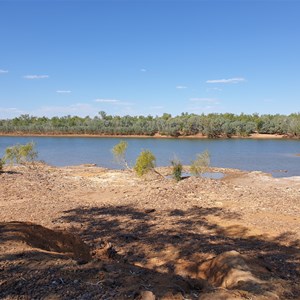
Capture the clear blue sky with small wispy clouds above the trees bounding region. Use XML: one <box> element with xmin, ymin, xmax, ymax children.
<box><xmin>0</xmin><ymin>0</ymin><xmax>300</xmax><ymax>118</ymax></box>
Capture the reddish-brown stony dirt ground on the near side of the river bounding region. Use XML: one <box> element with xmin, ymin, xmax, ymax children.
<box><xmin>0</xmin><ymin>164</ymin><xmax>300</xmax><ymax>300</ymax></box>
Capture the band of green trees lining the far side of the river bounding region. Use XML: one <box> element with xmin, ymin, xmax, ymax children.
<box><xmin>0</xmin><ymin>111</ymin><xmax>300</xmax><ymax>138</ymax></box>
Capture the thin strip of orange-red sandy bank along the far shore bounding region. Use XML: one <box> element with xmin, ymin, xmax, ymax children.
<box><xmin>0</xmin><ymin>132</ymin><xmax>292</xmax><ymax>139</ymax></box>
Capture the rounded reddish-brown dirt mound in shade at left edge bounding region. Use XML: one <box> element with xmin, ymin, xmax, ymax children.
<box><xmin>0</xmin><ymin>222</ymin><xmax>91</xmax><ymax>262</ymax></box>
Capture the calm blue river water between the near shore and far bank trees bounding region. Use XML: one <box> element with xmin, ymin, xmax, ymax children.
<box><xmin>0</xmin><ymin>137</ymin><xmax>300</xmax><ymax>177</ymax></box>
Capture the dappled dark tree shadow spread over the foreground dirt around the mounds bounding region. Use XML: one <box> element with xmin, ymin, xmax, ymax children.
<box><xmin>0</xmin><ymin>206</ymin><xmax>300</xmax><ymax>299</ymax></box>
